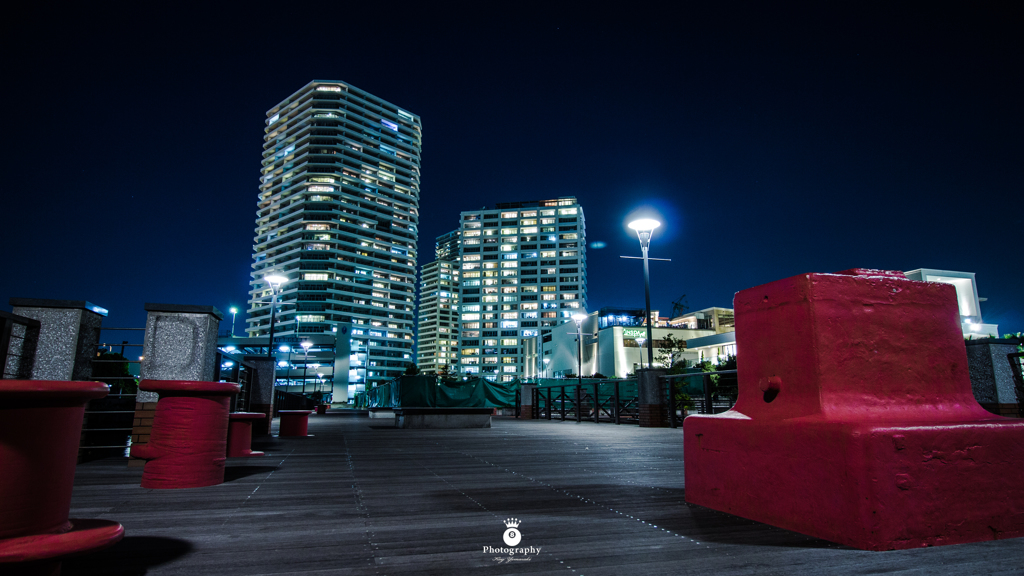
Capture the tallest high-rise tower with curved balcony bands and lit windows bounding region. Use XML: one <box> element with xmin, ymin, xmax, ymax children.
<box><xmin>247</xmin><ymin>80</ymin><xmax>422</xmax><ymax>393</ymax></box>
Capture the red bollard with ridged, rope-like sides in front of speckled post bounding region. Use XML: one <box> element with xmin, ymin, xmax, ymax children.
<box><xmin>131</xmin><ymin>380</ymin><xmax>241</xmax><ymax>489</ymax></box>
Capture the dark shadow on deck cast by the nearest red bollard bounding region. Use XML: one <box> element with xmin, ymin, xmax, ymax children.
<box><xmin>60</xmin><ymin>536</ymin><xmax>193</xmax><ymax>576</ymax></box>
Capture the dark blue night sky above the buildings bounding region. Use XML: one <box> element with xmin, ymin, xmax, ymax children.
<box><xmin>0</xmin><ymin>2</ymin><xmax>1024</xmax><ymax>332</ymax></box>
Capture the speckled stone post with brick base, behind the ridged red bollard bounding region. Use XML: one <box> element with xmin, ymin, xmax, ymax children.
<box><xmin>128</xmin><ymin>303</ymin><xmax>224</xmax><ymax>466</ymax></box>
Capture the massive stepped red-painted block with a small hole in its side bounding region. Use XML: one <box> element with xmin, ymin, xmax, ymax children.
<box><xmin>684</xmin><ymin>270</ymin><xmax>1024</xmax><ymax>550</ymax></box>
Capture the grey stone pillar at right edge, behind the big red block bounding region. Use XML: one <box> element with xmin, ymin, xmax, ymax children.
<box><xmin>966</xmin><ymin>338</ymin><xmax>1021</xmax><ymax>416</ymax></box>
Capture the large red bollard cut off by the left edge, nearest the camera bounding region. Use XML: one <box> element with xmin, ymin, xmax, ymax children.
<box><xmin>0</xmin><ymin>380</ymin><xmax>124</xmax><ymax>574</ymax></box>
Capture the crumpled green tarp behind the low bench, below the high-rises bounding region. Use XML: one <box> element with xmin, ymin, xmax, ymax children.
<box><xmin>356</xmin><ymin>376</ymin><xmax>519</xmax><ymax>408</ymax></box>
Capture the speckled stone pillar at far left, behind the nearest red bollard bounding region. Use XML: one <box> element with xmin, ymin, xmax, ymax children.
<box><xmin>9</xmin><ymin>298</ymin><xmax>106</xmax><ymax>380</ymax></box>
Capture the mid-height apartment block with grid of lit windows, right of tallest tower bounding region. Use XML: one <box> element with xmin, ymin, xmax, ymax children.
<box><xmin>459</xmin><ymin>197</ymin><xmax>587</xmax><ymax>381</ymax></box>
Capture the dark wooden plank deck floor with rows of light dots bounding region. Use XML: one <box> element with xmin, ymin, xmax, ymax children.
<box><xmin>65</xmin><ymin>413</ymin><xmax>1024</xmax><ymax>576</ymax></box>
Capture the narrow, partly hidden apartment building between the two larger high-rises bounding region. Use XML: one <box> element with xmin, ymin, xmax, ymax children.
<box><xmin>416</xmin><ymin>230</ymin><xmax>460</xmax><ymax>374</ymax></box>
